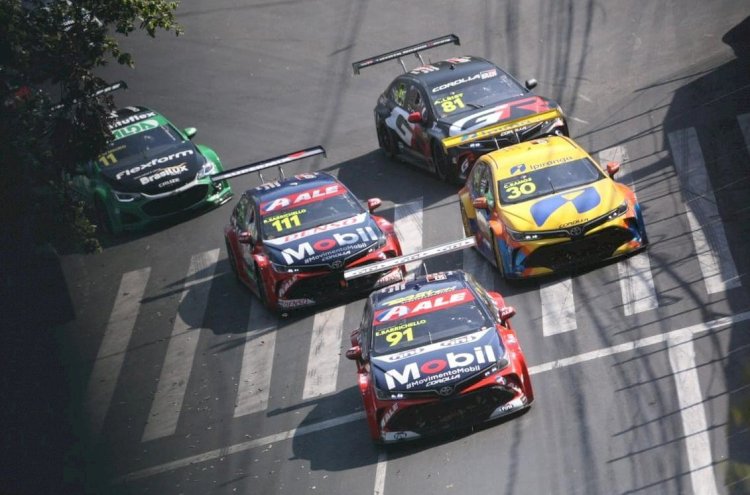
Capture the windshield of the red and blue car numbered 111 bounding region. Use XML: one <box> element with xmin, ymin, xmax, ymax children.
<box><xmin>261</xmin><ymin>185</ymin><xmax>364</xmax><ymax>240</ymax></box>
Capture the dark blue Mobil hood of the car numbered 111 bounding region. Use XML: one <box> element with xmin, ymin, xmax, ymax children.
<box><xmin>264</xmin><ymin>212</ymin><xmax>383</xmax><ymax>269</ymax></box>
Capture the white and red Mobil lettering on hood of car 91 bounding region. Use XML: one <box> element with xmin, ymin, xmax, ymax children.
<box><xmin>384</xmin><ymin>344</ymin><xmax>497</xmax><ymax>390</ymax></box>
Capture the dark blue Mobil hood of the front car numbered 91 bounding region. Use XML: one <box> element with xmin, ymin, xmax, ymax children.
<box><xmin>371</xmin><ymin>327</ymin><xmax>505</xmax><ymax>396</ymax></box>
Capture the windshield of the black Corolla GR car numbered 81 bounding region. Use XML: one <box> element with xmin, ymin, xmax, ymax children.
<box><xmin>430</xmin><ymin>69</ymin><xmax>526</xmax><ymax>118</ymax></box>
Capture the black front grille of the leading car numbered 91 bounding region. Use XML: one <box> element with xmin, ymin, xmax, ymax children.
<box><xmin>388</xmin><ymin>386</ymin><xmax>515</xmax><ymax>435</ymax></box>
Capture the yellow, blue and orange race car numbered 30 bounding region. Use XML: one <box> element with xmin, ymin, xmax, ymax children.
<box><xmin>458</xmin><ymin>136</ymin><xmax>648</xmax><ymax>278</ymax></box>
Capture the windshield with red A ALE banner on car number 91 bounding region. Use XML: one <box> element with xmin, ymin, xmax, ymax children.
<box><xmin>372</xmin><ymin>283</ymin><xmax>492</xmax><ymax>355</ymax></box>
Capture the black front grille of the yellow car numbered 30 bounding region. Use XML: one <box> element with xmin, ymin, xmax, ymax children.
<box><xmin>524</xmin><ymin>227</ymin><xmax>633</xmax><ymax>269</ymax></box>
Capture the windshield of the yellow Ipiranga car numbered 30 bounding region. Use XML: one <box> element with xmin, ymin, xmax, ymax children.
<box><xmin>497</xmin><ymin>158</ymin><xmax>604</xmax><ymax>205</ymax></box>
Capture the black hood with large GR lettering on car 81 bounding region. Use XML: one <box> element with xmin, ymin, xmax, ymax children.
<box><xmin>437</xmin><ymin>96</ymin><xmax>559</xmax><ymax>136</ymax></box>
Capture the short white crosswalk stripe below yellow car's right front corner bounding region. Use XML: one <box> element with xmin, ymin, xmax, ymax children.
<box><xmin>617</xmin><ymin>253</ymin><xmax>659</xmax><ymax>316</ymax></box>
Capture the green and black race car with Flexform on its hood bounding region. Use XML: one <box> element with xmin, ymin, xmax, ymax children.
<box><xmin>70</xmin><ymin>107</ymin><xmax>232</xmax><ymax>234</ymax></box>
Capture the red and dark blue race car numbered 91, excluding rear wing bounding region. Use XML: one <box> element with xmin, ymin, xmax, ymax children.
<box><xmin>346</xmin><ymin>271</ymin><xmax>534</xmax><ymax>443</ymax></box>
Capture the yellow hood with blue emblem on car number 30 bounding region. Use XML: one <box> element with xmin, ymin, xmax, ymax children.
<box><xmin>500</xmin><ymin>179</ymin><xmax>625</xmax><ymax>232</ymax></box>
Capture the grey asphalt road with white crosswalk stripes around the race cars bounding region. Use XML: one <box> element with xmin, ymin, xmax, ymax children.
<box><xmin>10</xmin><ymin>0</ymin><xmax>750</xmax><ymax>495</ymax></box>
